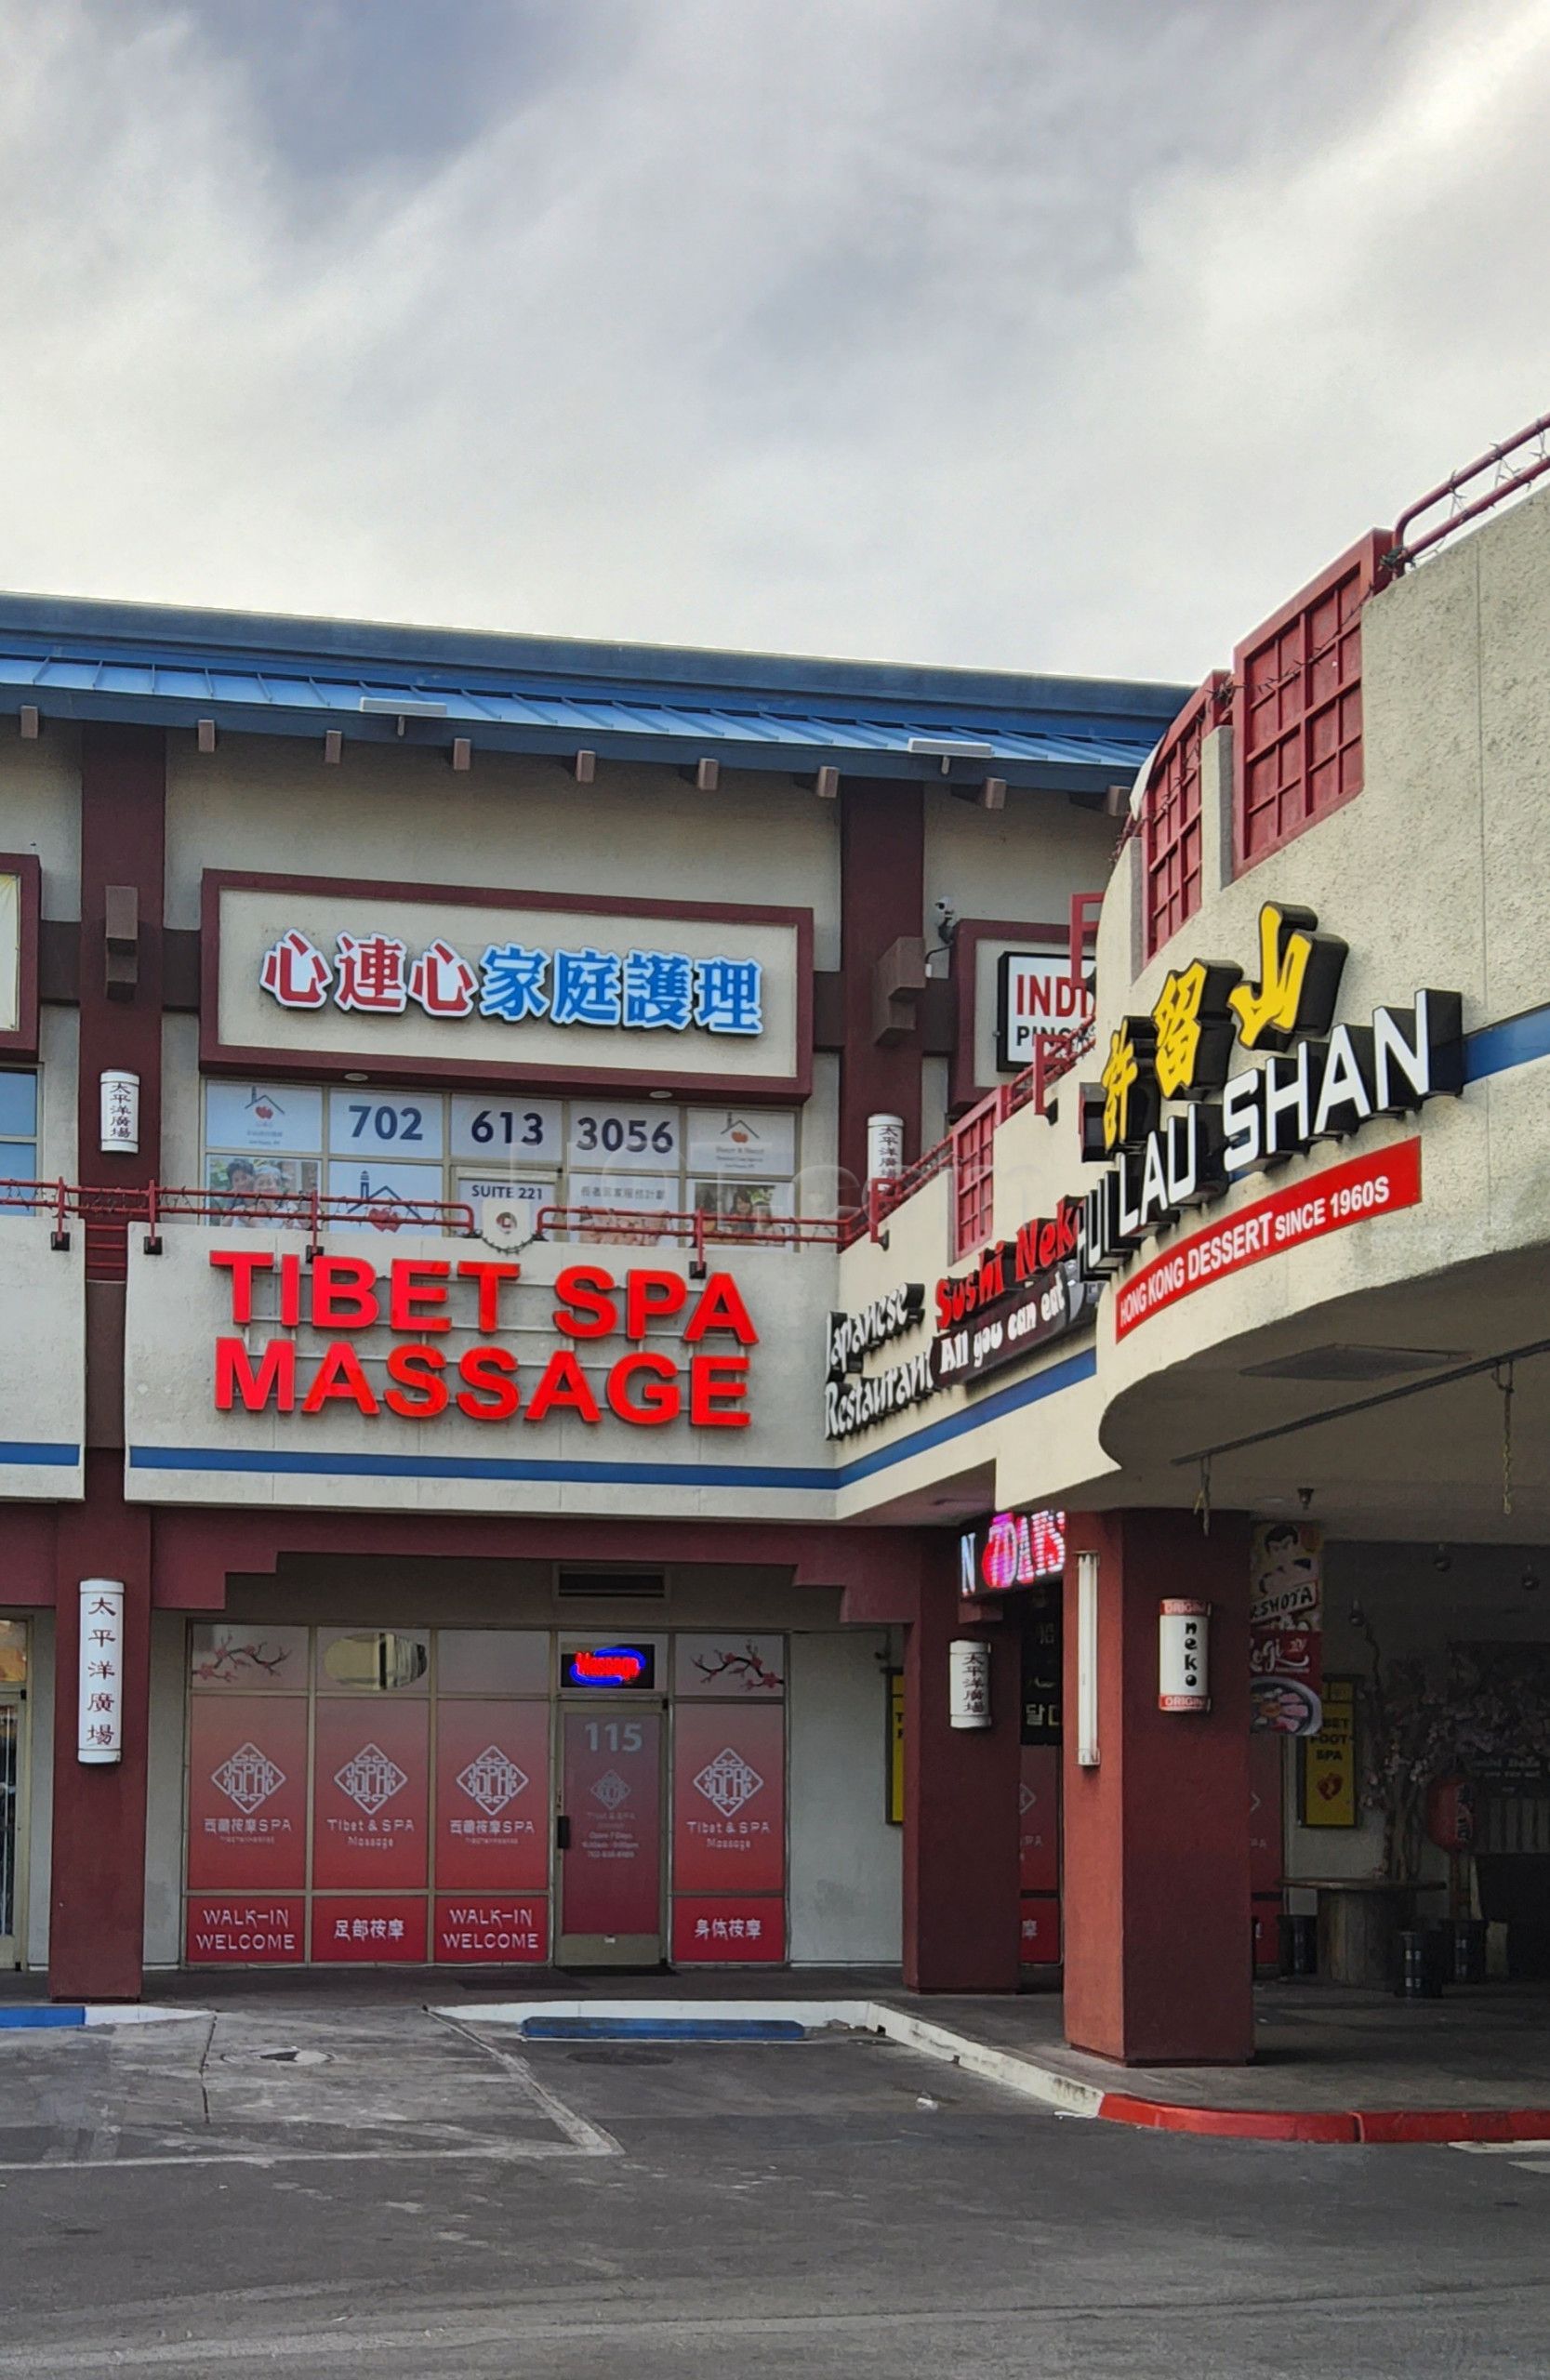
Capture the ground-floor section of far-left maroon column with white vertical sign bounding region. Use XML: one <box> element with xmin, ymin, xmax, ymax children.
<box><xmin>47</xmin><ymin>1452</ymin><xmax>150</xmax><ymax>1999</ymax></box>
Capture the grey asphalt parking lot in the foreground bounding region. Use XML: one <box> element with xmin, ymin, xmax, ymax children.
<box><xmin>0</xmin><ymin>2006</ymin><xmax>1550</xmax><ymax>2380</ymax></box>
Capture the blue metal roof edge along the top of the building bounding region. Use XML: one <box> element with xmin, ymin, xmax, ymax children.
<box><xmin>0</xmin><ymin>595</ymin><xmax>1188</xmax><ymax>792</ymax></box>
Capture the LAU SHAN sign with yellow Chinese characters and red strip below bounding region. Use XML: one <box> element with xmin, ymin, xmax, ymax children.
<box><xmin>1081</xmin><ymin>902</ymin><xmax>1464</xmax><ymax>1338</ymax></box>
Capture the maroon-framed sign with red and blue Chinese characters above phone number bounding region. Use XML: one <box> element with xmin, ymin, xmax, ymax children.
<box><xmin>203</xmin><ymin>876</ymin><xmax>812</xmax><ymax>1092</ymax></box>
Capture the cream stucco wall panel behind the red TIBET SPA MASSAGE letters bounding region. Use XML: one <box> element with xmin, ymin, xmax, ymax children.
<box><xmin>124</xmin><ymin>1223</ymin><xmax>833</xmax><ymax>1521</ymax></box>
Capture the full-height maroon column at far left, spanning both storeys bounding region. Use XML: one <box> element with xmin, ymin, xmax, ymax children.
<box><xmin>47</xmin><ymin>726</ymin><xmax>166</xmax><ymax>1999</ymax></box>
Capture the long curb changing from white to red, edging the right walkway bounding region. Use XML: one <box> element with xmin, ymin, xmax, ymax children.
<box><xmin>452</xmin><ymin>1999</ymin><xmax>1550</xmax><ymax>2149</ymax></box>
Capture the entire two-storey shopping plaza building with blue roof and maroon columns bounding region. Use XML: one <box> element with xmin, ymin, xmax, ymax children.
<box><xmin>0</xmin><ymin>438</ymin><xmax>1550</xmax><ymax>2058</ymax></box>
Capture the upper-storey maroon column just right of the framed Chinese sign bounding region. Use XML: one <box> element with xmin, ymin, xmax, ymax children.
<box><xmin>841</xmin><ymin>776</ymin><xmax>926</xmax><ymax>1204</ymax></box>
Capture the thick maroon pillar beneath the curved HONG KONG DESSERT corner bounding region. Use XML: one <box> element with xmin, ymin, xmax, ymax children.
<box><xmin>1062</xmin><ymin>1512</ymin><xmax>1254</xmax><ymax>2066</ymax></box>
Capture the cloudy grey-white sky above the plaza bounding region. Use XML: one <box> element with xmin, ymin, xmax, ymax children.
<box><xmin>0</xmin><ymin>0</ymin><xmax>1550</xmax><ymax>681</ymax></box>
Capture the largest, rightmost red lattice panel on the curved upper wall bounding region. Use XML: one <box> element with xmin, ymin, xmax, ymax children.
<box><xmin>1233</xmin><ymin>528</ymin><xmax>1393</xmax><ymax>868</ymax></box>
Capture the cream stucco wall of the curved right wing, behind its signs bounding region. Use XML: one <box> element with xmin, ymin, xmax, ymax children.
<box><xmin>841</xmin><ymin>481</ymin><xmax>1550</xmax><ymax>1514</ymax></box>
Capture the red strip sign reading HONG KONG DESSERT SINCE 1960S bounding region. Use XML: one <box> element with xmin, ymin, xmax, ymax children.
<box><xmin>1114</xmin><ymin>1140</ymin><xmax>1422</xmax><ymax>1338</ymax></box>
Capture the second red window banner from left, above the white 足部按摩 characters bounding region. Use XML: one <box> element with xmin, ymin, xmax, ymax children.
<box><xmin>311</xmin><ymin>1695</ymin><xmax>431</xmax><ymax>1884</ymax></box>
